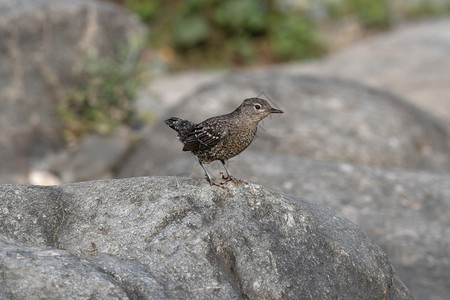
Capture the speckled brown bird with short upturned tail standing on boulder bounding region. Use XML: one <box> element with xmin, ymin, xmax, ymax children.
<box><xmin>164</xmin><ymin>97</ymin><xmax>283</xmax><ymax>186</ymax></box>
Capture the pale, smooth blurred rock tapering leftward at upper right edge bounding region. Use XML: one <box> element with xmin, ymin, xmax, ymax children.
<box><xmin>283</xmin><ymin>17</ymin><xmax>450</xmax><ymax>122</ymax></box>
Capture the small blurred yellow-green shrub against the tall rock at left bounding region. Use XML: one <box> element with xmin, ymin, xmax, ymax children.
<box><xmin>58</xmin><ymin>58</ymin><xmax>137</xmax><ymax>141</ymax></box>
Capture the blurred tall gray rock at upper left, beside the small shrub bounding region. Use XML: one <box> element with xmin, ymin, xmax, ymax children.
<box><xmin>0</xmin><ymin>0</ymin><xmax>145</xmax><ymax>182</ymax></box>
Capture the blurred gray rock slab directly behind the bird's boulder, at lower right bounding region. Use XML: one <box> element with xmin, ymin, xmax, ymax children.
<box><xmin>127</xmin><ymin>151</ymin><xmax>450</xmax><ymax>300</ymax></box>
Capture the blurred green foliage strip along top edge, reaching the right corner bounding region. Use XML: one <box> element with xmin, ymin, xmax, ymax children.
<box><xmin>115</xmin><ymin>0</ymin><xmax>450</xmax><ymax>68</ymax></box>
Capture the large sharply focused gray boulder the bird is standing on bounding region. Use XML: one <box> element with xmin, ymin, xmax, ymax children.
<box><xmin>0</xmin><ymin>177</ymin><xmax>412</xmax><ymax>299</ymax></box>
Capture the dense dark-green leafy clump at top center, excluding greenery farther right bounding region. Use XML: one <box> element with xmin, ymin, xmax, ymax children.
<box><xmin>125</xmin><ymin>0</ymin><xmax>325</xmax><ymax>67</ymax></box>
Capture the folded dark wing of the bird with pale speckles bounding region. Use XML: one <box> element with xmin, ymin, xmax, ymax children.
<box><xmin>183</xmin><ymin>121</ymin><xmax>227</xmax><ymax>151</ymax></box>
